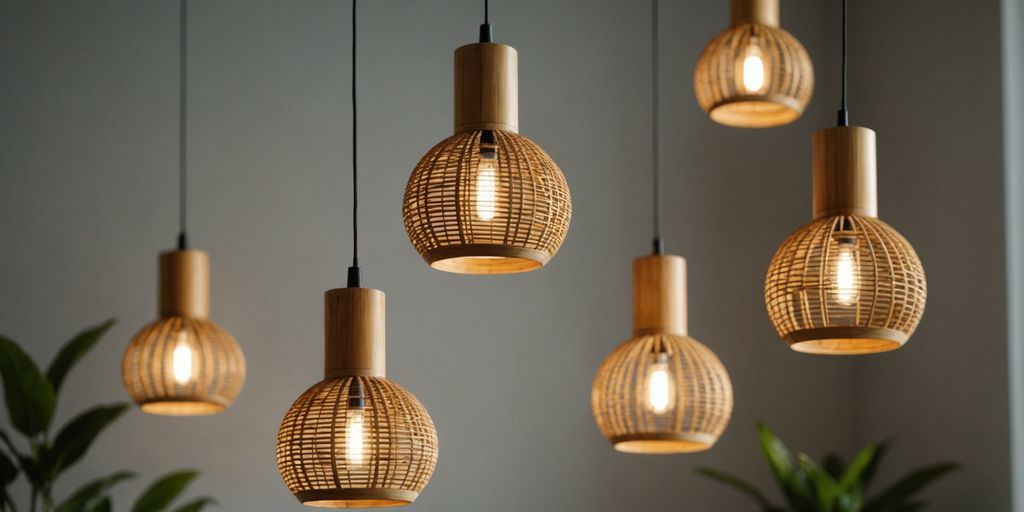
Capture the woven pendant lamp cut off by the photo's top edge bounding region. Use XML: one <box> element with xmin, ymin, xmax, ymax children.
<box><xmin>693</xmin><ymin>0</ymin><xmax>814</xmax><ymax>128</ymax></box>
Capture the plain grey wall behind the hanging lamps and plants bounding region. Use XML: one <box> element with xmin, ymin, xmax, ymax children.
<box><xmin>0</xmin><ymin>0</ymin><xmax>1010</xmax><ymax>512</ymax></box>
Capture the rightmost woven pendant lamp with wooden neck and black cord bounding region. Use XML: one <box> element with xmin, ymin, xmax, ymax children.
<box><xmin>765</xmin><ymin>0</ymin><xmax>927</xmax><ymax>354</ymax></box>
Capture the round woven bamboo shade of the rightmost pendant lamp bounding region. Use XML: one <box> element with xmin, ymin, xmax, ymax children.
<box><xmin>765</xmin><ymin>215</ymin><xmax>927</xmax><ymax>353</ymax></box>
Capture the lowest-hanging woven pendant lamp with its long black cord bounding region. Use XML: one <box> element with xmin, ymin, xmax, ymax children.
<box><xmin>276</xmin><ymin>0</ymin><xmax>437</xmax><ymax>508</ymax></box>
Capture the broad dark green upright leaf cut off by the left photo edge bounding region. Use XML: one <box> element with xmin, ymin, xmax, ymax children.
<box><xmin>0</xmin><ymin>336</ymin><xmax>56</xmax><ymax>437</ymax></box>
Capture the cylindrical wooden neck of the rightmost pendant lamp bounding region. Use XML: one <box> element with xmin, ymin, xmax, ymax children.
<box><xmin>812</xmin><ymin>126</ymin><xmax>879</xmax><ymax>219</ymax></box>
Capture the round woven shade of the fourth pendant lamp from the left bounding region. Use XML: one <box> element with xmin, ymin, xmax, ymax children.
<box><xmin>591</xmin><ymin>334</ymin><xmax>732</xmax><ymax>454</ymax></box>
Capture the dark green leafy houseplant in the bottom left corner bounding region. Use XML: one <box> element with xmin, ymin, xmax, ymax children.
<box><xmin>0</xmin><ymin>321</ymin><xmax>213</xmax><ymax>512</ymax></box>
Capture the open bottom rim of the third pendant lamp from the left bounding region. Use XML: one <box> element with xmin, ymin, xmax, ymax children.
<box><xmin>423</xmin><ymin>244</ymin><xmax>551</xmax><ymax>273</ymax></box>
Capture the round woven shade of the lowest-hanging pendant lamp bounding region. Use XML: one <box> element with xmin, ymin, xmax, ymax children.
<box><xmin>276</xmin><ymin>377</ymin><xmax>437</xmax><ymax>508</ymax></box>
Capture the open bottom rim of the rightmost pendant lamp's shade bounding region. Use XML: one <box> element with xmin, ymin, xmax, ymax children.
<box><xmin>786</xmin><ymin>327</ymin><xmax>908</xmax><ymax>355</ymax></box>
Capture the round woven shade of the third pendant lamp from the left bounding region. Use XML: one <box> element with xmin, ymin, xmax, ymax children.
<box><xmin>402</xmin><ymin>130</ymin><xmax>571</xmax><ymax>273</ymax></box>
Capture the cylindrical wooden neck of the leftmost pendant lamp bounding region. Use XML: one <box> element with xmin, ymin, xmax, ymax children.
<box><xmin>159</xmin><ymin>249</ymin><xmax>210</xmax><ymax>318</ymax></box>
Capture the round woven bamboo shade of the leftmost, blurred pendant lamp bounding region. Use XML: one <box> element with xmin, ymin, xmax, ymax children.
<box><xmin>122</xmin><ymin>316</ymin><xmax>246</xmax><ymax>416</ymax></box>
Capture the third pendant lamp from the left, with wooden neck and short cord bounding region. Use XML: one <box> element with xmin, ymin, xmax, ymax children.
<box><xmin>401</xmin><ymin>0</ymin><xmax>572</xmax><ymax>273</ymax></box>
